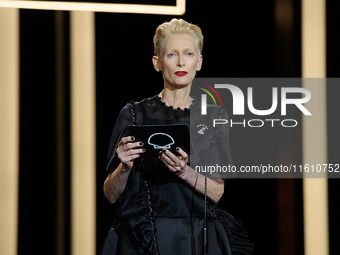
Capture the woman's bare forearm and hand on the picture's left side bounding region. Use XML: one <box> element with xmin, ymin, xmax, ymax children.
<box><xmin>104</xmin><ymin>136</ymin><xmax>145</xmax><ymax>203</ymax></box>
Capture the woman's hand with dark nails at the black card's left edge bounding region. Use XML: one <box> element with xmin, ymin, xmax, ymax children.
<box><xmin>116</xmin><ymin>136</ymin><xmax>145</xmax><ymax>172</ymax></box>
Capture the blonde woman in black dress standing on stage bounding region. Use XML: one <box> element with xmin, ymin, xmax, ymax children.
<box><xmin>103</xmin><ymin>19</ymin><xmax>252</xmax><ymax>255</ymax></box>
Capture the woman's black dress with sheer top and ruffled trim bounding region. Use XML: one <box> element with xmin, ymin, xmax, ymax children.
<box><xmin>102</xmin><ymin>96</ymin><xmax>252</xmax><ymax>255</ymax></box>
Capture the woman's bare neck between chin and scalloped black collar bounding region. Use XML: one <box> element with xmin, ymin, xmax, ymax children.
<box><xmin>159</xmin><ymin>87</ymin><xmax>192</xmax><ymax>109</ymax></box>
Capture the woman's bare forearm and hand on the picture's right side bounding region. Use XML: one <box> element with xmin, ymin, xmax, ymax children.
<box><xmin>160</xmin><ymin>148</ymin><xmax>224</xmax><ymax>203</ymax></box>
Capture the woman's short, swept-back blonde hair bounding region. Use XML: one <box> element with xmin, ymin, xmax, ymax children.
<box><xmin>153</xmin><ymin>19</ymin><xmax>203</xmax><ymax>58</ymax></box>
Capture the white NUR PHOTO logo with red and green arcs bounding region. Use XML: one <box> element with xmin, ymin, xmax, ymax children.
<box><xmin>194</xmin><ymin>79</ymin><xmax>312</xmax><ymax>128</ymax></box>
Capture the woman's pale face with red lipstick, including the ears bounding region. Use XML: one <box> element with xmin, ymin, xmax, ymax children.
<box><xmin>153</xmin><ymin>34</ymin><xmax>202</xmax><ymax>88</ymax></box>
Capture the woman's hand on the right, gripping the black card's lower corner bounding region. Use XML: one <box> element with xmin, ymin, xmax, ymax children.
<box><xmin>159</xmin><ymin>147</ymin><xmax>188</xmax><ymax>177</ymax></box>
